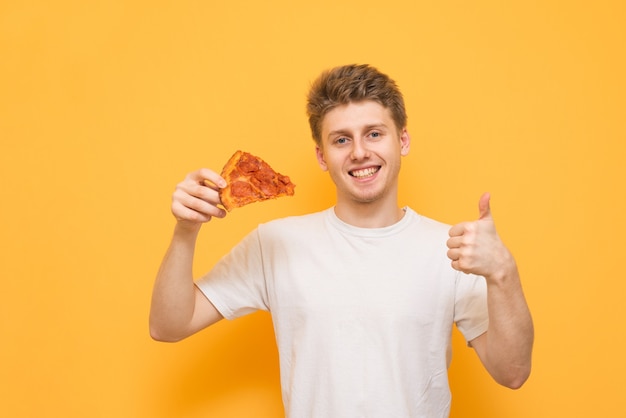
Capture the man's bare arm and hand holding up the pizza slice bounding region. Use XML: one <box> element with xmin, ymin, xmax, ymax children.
<box><xmin>150</xmin><ymin>169</ymin><xmax>226</xmax><ymax>341</ymax></box>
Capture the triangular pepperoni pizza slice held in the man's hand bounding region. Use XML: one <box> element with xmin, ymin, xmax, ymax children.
<box><xmin>213</xmin><ymin>151</ymin><xmax>296</xmax><ymax>211</ymax></box>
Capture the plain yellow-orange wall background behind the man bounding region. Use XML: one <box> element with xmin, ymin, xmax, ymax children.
<box><xmin>0</xmin><ymin>0</ymin><xmax>626</xmax><ymax>418</ymax></box>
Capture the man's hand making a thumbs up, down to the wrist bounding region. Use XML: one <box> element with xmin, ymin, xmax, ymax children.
<box><xmin>447</xmin><ymin>193</ymin><xmax>517</xmax><ymax>280</ymax></box>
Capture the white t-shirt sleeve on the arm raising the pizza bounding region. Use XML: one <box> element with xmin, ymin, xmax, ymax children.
<box><xmin>196</xmin><ymin>229</ymin><xmax>268</xmax><ymax>319</ymax></box>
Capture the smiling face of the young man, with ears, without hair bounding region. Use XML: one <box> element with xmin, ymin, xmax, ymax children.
<box><xmin>316</xmin><ymin>101</ymin><xmax>410</xmax><ymax>203</ymax></box>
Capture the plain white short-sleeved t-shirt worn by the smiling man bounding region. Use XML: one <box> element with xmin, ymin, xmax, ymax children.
<box><xmin>197</xmin><ymin>208</ymin><xmax>488</xmax><ymax>418</ymax></box>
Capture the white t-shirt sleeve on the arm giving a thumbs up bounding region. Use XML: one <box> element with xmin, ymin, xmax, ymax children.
<box><xmin>454</xmin><ymin>272</ymin><xmax>489</xmax><ymax>343</ymax></box>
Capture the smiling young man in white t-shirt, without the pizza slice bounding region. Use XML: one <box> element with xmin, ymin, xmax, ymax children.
<box><xmin>150</xmin><ymin>65</ymin><xmax>533</xmax><ymax>418</ymax></box>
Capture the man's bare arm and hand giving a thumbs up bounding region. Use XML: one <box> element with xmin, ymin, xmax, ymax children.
<box><xmin>448</xmin><ymin>194</ymin><xmax>534</xmax><ymax>389</ymax></box>
